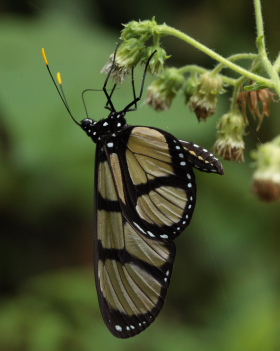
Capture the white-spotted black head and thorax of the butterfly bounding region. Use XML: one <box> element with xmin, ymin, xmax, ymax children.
<box><xmin>81</xmin><ymin>111</ymin><xmax>126</xmax><ymax>143</ymax></box>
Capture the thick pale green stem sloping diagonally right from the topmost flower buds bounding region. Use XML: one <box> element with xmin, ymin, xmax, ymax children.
<box><xmin>157</xmin><ymin>23</ymin><xmax>272</xmax><ymax>88</ymax></box>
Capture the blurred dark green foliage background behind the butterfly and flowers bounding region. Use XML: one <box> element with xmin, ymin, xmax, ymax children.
<box><xmin>0</xmin><ymin>0</ymin><xmax>280</xmax><ymax>351</ymax></box>
